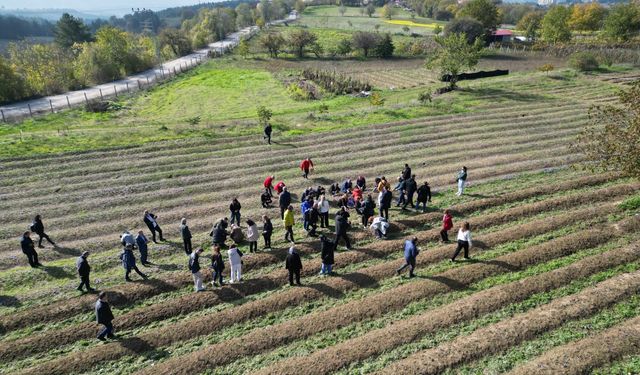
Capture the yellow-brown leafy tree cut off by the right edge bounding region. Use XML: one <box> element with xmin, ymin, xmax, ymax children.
<box><xmin>572</xmin><ymin>82</ymin><xmax>640</xmax><ymax>178</ymax></box>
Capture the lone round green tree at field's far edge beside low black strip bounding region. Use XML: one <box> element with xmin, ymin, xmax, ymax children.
<box><xmin>427</xmin><ymin>33</ymin><xmax>482</xmax><ymax>88</ymax></box>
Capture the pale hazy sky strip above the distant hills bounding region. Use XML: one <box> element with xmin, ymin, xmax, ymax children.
<box><xmin>0</xmin><ymin>0</ymin><xmax>220</xmax><ymax>13</ymax></box>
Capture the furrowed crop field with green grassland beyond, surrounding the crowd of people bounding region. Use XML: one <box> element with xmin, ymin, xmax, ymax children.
<box><xmin>0</xmin><ymin>3</ymin><xmax>640</xmax><ymax>375</ymax></box>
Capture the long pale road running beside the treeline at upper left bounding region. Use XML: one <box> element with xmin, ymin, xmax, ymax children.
<box><xmin>0</xmin><ymin>14</ymin><xmax>296</xmax><ymax>122</ymax></box>
